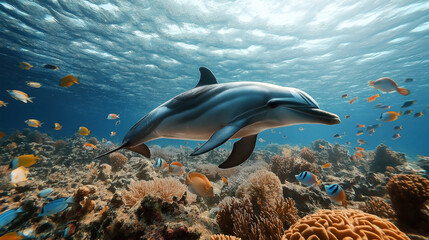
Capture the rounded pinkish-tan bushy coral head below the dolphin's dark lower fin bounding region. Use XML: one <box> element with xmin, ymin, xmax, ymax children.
<box><xmin>236</xmin><ymin>170</ymin><xmax>283</xmax><ymax>207</ymax></box>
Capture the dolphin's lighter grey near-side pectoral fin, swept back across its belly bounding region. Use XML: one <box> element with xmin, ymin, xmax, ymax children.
<box><xmin>191</xmin><ymin>120</ymin><xmax>245</xmax><ymax>156</ymax></box>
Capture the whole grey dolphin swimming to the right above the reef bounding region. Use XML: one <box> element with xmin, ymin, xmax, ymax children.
<box><xmin>97</xmin><ymin>67</ymin><xmax>340</xmax><ymax>168</ymax></box>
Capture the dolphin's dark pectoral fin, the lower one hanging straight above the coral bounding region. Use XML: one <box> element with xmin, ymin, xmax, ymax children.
<box><xmin>219</xmin><ymin>134</ymin><xmax>258</xmax><ymax>168</ymax></box>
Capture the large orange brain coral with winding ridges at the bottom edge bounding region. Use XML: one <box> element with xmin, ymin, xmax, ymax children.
<box><xmin>282</xmin><ymin>209</ymin><xmax>409</xmax><ymax>240</ymax></box>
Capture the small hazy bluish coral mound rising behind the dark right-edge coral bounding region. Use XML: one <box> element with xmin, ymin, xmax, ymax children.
<box><xmin>371</xmin><ymin>144</ymin><xmax>407</xmax><ymax>172</ymax></box>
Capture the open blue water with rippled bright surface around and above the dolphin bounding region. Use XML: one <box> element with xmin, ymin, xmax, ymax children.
<box><xmin>0</xmin><ymin>0</ymin><xmax>429</xmax><ymax>158</ymax></box>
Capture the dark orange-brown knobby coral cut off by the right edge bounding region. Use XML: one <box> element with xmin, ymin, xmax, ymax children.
<box><xmin>386</xmin><ymin>174</ymin><xmax>429</xmax><ymax>232</ymax></box>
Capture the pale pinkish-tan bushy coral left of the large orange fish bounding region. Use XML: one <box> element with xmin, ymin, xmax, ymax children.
<box><xmin>122</xmin><ymin>177</ymin><xmax>187</xmax><ymax>206</ymax></box>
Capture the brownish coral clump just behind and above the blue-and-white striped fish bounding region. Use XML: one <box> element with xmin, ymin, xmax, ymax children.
<box><xmin>271</xmin><ymin>155</ymin><xmax>319</xmax><ymax>182</ymax></box>
